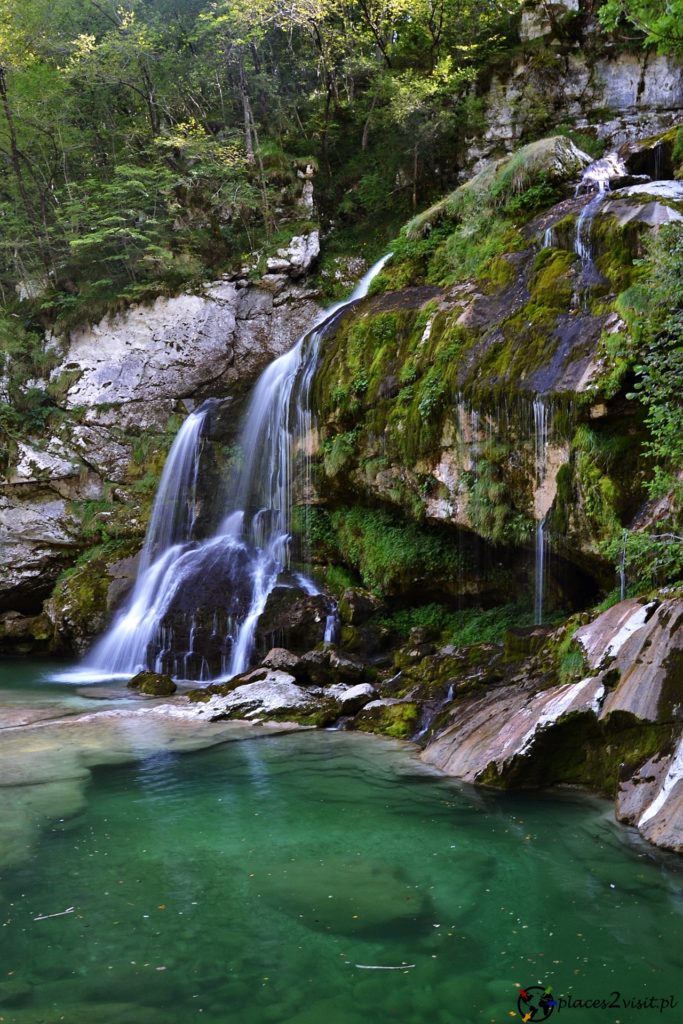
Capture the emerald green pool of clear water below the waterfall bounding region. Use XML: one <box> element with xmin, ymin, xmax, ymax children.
<box><xmin>0</xmin><ymin>675</ymin><xmax>683</xmax><ymax>1024</ymax></box>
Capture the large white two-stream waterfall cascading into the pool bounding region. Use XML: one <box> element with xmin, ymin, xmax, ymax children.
<box><xmin>66</xmin><ymin>254</ymin><xmax>390</xmax><ymax>681</ymax></box>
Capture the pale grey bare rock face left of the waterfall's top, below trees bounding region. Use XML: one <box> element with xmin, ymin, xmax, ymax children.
<box><xmin>52</xmin><ymin>262</ymin><xmax>319</xmax><ymax>413</ymax></box>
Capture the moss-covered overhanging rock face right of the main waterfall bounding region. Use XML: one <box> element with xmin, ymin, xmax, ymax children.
<box><xmin>315</xmin><ymin>136</ymin><xmax>683</xmax><ymax>607</ymax></box>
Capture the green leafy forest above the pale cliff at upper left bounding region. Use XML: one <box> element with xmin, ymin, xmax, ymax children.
<box><xmin>0</xmin><ymin>0</ymin><xmax>520</xmax><ymax>326</ymax></box>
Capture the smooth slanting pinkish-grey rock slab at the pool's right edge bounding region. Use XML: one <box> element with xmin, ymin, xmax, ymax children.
<box><xmin>422</xmin><ymin>597</ymin><xmax>683</xmax><ymax>852</ymax></box>
